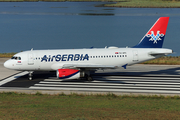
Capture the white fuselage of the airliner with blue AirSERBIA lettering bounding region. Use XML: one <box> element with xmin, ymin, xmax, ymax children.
<box><xmin>4</xmin><ymin>48</ymin><xmax>172</xmax><ymax>71</ymax></box>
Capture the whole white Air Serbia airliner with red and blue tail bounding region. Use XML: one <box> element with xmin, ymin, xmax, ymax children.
<box><xmin>4</xmin><ymin>17</ymin><xmax>172</xmax><ymax>81</ymax></box>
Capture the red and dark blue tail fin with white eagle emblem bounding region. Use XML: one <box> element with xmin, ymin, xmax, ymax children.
<box><xmin>133</xmin><ymin>17</ymin><xmax>169</xmax><ymax>48</ymax></box>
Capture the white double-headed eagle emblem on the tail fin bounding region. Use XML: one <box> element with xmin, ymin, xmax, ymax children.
<box><xmin>146</xmin><ymin>31</ymin><xmax>164</xmax><ymax>44</ymax></box>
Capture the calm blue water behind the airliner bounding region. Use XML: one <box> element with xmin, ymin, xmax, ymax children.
<box><xmin>0</xmin><ymin>2</ymin><xmax>180</xmax><ymax>56</ymax></box>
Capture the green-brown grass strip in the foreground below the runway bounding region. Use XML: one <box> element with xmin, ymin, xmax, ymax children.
<box><xmin>0</xmin><ymin>92</ymin><xmax>180</xmax><ymax>120</ymax></box>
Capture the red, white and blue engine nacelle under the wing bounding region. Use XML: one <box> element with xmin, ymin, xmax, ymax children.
<box><xmin>56</xmin><ymin>69</ymin><xmax>84</xmax><ymax>79</ymax></box>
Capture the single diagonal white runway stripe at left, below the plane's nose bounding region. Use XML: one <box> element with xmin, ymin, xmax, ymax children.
<box><xmin>0</xmin><ymin>71</ymin><xmax>28</xmax><ymax>86</ymax></box>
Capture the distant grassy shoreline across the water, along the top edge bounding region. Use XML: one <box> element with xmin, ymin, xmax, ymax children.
<box><xmin>0</xmin><ymin>0</ymin><xmax>180</xmax><ymax>8</ymax></box>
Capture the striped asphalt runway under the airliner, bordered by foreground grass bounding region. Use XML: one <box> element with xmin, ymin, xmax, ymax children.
<box><xmin>0</xmin><ymin>62</ymin><xmax>180</xmax><ymax>94</ymax></box>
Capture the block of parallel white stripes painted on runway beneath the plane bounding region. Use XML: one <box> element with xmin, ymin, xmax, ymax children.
<box><xmin>30</xmin><ymin>76</ymin><xmax>180</xmax><ymax>94</ymax></box>
